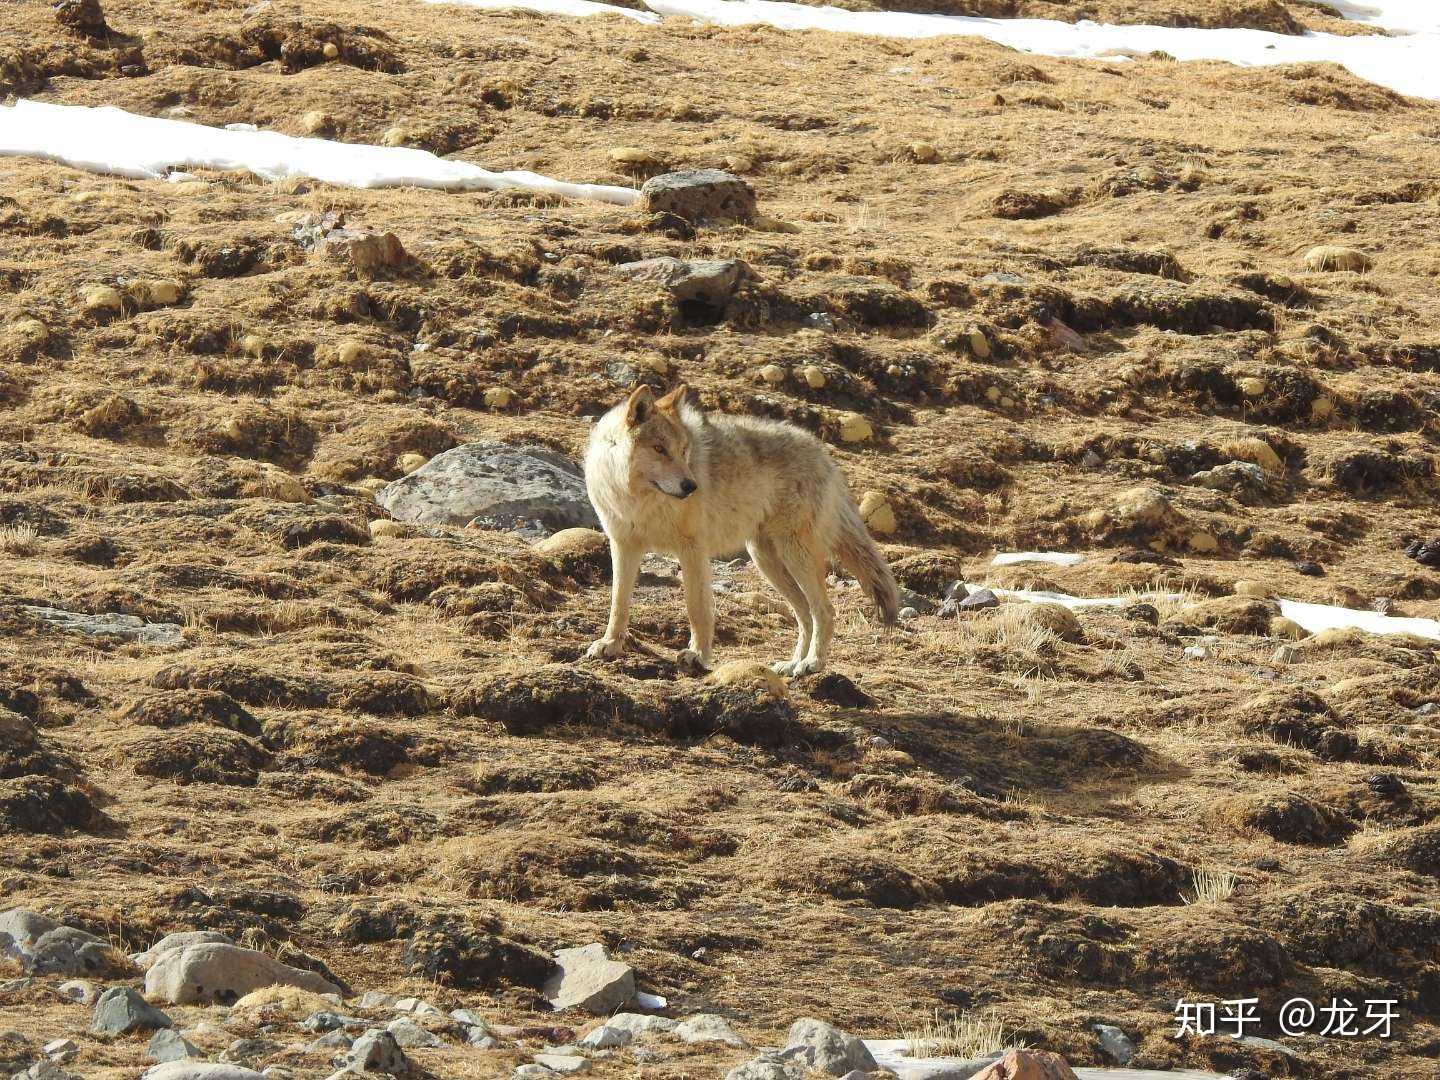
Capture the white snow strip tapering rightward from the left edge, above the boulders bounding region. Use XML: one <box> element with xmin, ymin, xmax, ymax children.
<box><xmin>0</xmin><ymin>99</ymin><xmax>639</xmax><ymax>206</ymax></box>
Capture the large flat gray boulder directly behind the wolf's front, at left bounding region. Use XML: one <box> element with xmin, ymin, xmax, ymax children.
<box><xmin>374</xmin><ymin>441</ymin><xmax>600</xmax><ymax>531</ymax></box>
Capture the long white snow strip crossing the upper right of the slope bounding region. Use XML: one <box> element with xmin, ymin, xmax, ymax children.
<box><xmin>645</xmin><ymin>0</ymin><xmax>1440</xmax><ymax>99</ymax></box>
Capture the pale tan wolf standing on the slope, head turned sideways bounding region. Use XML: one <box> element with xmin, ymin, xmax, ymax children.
<box><xmin>585</xmin><ymin>383</ymin><xmax>900</xmax><ymax>677</ymax></box>
